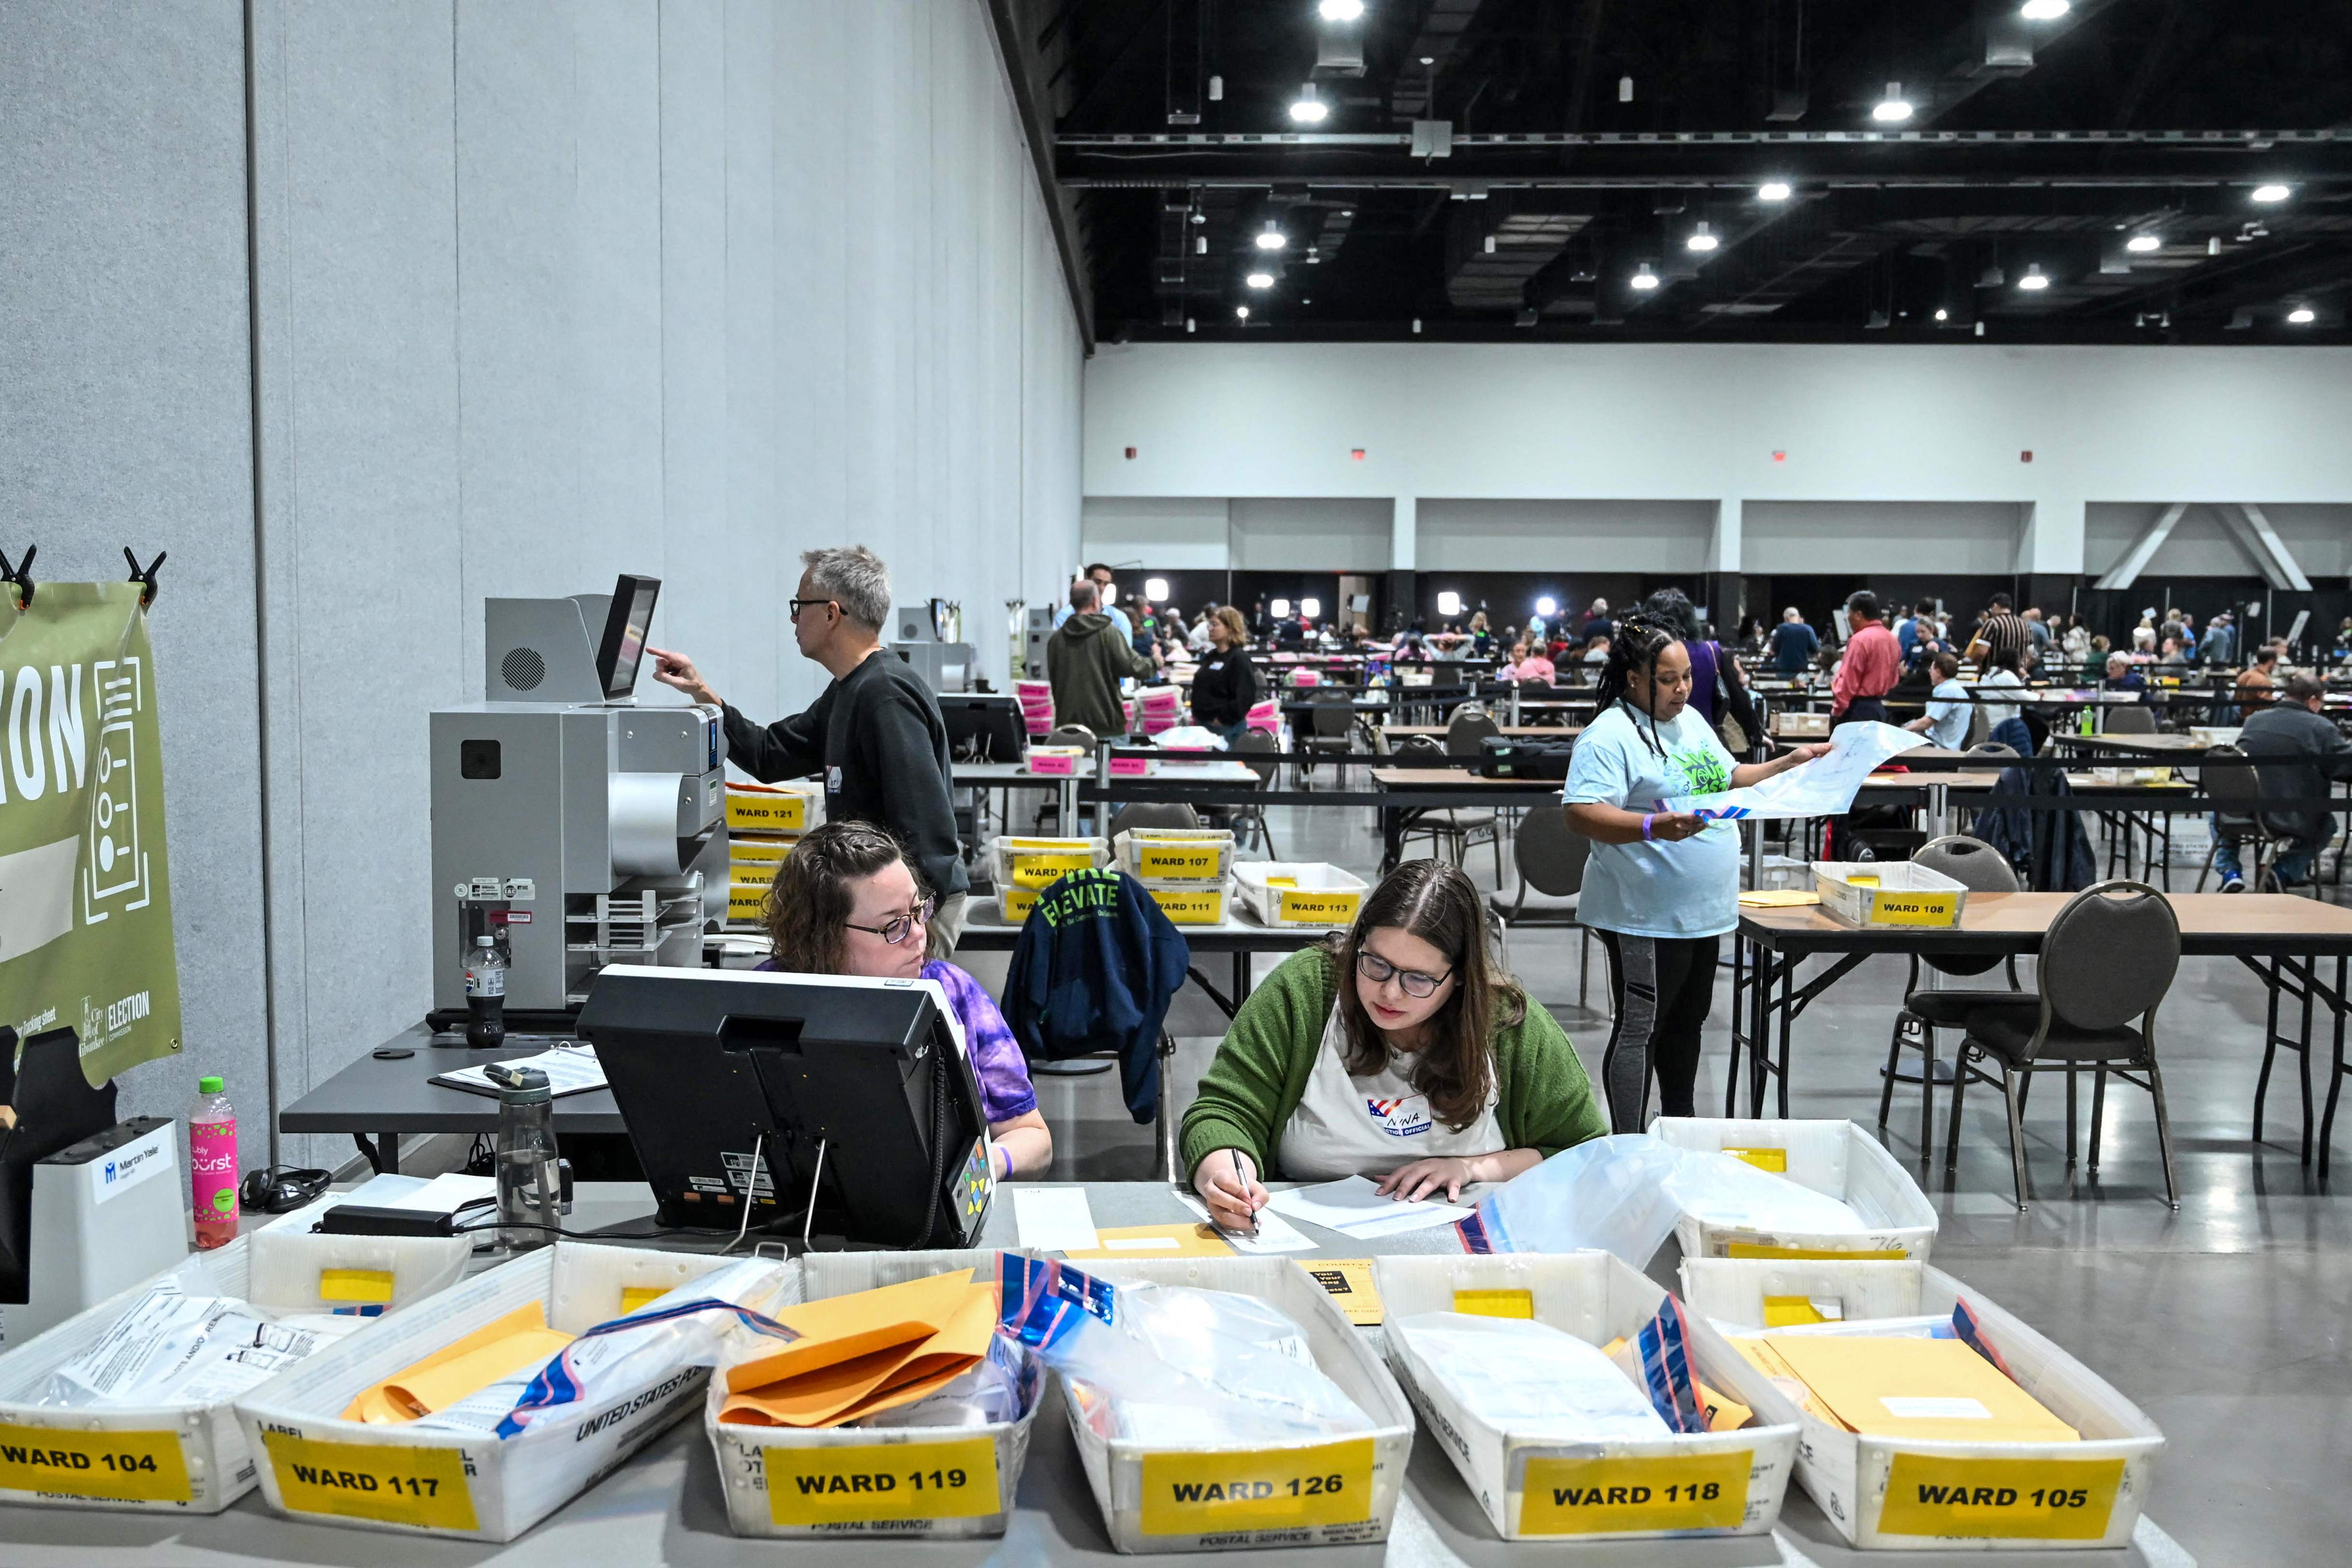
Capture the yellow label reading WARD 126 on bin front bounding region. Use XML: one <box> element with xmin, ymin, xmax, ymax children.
<box><xmin>1143</xmin><ymin>1436</ymin><xmax>1373</xmax><ymax>1535</ymax></box>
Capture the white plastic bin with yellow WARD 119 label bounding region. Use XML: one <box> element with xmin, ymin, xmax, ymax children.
<box><xmin>703</xmin><ymin>1251</ymin><xmax>1047</xmax><ymax>1540</ymax></box>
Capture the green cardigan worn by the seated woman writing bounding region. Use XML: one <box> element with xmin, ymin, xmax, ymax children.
<box><xmin>1183</xmin><ymin>947</ymin><xmax>1609</xmax><ymax>1178</ymax></box>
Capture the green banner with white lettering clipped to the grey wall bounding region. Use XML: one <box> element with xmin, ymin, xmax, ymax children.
<box><xmin>0</xmin><ymin>583</ymin><xmax>179</xmax><ymax>1086</ymax></box>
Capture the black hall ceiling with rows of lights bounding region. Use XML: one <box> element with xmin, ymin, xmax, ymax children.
<box><xmin>1020</xmin><ymin>0</ymin><xmax>2352</xmax><ymax>343</ymax></box>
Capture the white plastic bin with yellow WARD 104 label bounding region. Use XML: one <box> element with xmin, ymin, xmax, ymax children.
<box><xmin>0</xmin><ymin>1225</ymin><xmax>473</xmax><ymax>1514</ymax></box>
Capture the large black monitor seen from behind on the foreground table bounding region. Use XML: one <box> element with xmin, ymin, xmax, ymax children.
<box><xmin>579</xmin><ymin>964</ymin><xmax>992</xmax><ymax>1246</ymax></box>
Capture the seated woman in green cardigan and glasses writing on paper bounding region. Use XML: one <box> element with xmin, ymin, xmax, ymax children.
<box><xmin>1183</xmin><ymin>860</ymin><xmax>1609</xmax><ymax>1230</ymax></box>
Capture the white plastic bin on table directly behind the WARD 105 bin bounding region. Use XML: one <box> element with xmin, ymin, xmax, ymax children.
<box><xmin>1649</xmin><ymin>1117</ymin><xmax>1938</xmax><ymax>1262</ymax></box>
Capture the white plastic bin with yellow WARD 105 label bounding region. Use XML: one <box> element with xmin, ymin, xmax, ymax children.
<box><xmin>1682</xmin><ymin>1257</ymin><xmax>2164</xmax><ymax>1549</ymax></box>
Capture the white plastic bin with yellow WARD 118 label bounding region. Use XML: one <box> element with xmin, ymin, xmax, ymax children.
<box><xmin>1371</xmin><ymin>1253</ymin><xmax>1797</xmax><ymax>1540</ymax></box>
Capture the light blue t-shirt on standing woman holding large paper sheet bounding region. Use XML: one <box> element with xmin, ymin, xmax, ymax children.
<box><xmin>1559</xmin><ymin>703</ymin><xmax>1740</xmax><ymax>938</ymax></box>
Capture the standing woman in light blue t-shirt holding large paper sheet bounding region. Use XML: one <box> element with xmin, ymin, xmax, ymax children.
<box><xmin>1562</xmin><ymin>614</ymin><xmax>1830</xmax><ymax>1133</ymax></box>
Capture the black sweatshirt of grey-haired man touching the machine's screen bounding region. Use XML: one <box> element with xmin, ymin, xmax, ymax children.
<box><xmin>727</xmin><ymin>649</ymin><xmax>971</xmax><ymax>898</ymax></box>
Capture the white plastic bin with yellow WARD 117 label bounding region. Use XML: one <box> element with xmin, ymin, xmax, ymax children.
<box><xmin>238</xmin><ymin>1241</ymin><xmax>786</xmax><ymax>1542</ymax></box>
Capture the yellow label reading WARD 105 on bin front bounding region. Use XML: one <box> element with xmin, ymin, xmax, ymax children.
<box><xmin>1879</xmin><ymin>1453</ymin><xmax>2124</xmax><ymax>1540</ymax></box>
